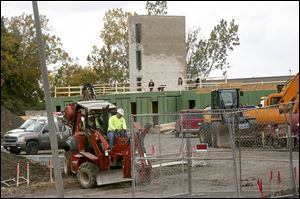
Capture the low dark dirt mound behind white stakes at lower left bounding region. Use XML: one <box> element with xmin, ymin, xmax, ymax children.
<box><xmin>1</xmin><ymin>152</ymin><xmax>50</xmax><ymax>182</ymax></box>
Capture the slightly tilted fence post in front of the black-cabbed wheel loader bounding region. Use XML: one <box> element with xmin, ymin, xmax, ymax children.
<box><xmin>228</xmin><ymin>114</ymin><xmax>240</xmax><ymax>198</ymax></box>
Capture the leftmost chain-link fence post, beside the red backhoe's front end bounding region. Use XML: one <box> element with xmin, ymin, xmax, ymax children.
<box><xmin>130</xmin><ymin>114</ymin><xmax>136</xmax><ymax>198</ymax></box>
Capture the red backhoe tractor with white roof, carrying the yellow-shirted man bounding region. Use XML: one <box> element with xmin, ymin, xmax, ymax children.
<box><xmin>64</xmin><ymin>83</ymin><xmax>152</xmax><ymax>188</ymax></box>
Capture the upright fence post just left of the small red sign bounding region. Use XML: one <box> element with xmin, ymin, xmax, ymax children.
<box><xmin>186</xmin><ymin>112</ymin><xmax>192</xmax><ymax>195</ymax></box>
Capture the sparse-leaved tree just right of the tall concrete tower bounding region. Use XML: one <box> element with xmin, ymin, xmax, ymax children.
<box><xmin>186</xmin><ymin>19</ymin><xmax>240</xmax><ymax>78</ymax></box>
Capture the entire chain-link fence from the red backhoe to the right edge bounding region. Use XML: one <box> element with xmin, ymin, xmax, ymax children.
<box><xmin>131</xmin><ymin>102</ymin><xmax>299</xmax><ymax>197</ymax></box>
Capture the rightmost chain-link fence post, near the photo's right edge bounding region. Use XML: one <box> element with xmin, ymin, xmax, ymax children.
<box><xmin>284</xmin><ymin>104</ymin><xmax>296</xmax><ymax>192</ymax></box>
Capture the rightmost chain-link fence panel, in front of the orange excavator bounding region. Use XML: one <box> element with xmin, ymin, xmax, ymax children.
<box><xmin>237</xmin><ymin>102</ymin><xmax>299</xmax><ymax>197</ymax></box>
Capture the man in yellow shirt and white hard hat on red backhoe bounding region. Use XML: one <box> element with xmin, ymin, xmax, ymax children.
<box><xmin>108</xmin><ymin>108</ymin><xmax>127</xmax><ymax>149</ymax></box>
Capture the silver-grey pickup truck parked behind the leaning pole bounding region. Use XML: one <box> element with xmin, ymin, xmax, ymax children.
<box><xmin>3</xmin><ymin>116</ymin><xmax>71</xmax><ymax>155</ymax></box>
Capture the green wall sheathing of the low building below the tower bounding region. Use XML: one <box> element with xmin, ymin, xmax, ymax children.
<box><xmin>52</xmin><ymin>90</ymin><xmax>277</xmax><ymax>125</ymax></box>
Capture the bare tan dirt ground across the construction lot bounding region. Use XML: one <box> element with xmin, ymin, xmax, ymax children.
<box><xmin>1</xmin><ymin>134</ymin><xmax>299</xmax><ymax>198</ymax></box>
